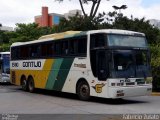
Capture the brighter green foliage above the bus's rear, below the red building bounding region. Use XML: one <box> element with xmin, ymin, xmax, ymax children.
<box><xmin>0</xmin><ymin>23</ymin><xmax>53</xmax><ymax>51</ymax></box>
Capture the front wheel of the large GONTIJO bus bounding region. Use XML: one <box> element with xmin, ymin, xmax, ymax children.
<box><xmin>77</xmin><ymin>81</ymin><xmax>90</xmax><ymax>100</ymax></box>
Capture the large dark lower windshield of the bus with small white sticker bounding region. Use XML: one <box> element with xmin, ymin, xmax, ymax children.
<box><xmin>113</xmin><ymin>50</ymin><xmax>151</xmax><ymax>78</ymax></box>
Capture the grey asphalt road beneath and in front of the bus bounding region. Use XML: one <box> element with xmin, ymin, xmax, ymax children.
<box><xmin>0</xmin><ymin>85</ymin><xmax>160</xmax><ymax>120</ymax></box>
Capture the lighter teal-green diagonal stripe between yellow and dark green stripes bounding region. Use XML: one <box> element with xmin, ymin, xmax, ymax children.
<box><xmin>46</xmin><ymin>59</ymin><xmax>63</xmax><ymax>90</ymax></box>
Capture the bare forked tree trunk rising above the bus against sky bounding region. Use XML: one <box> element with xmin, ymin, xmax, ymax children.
<box><xmin>55</xmin><ymin>0</ymin><xmax>109</xmax><ymax>20</ymax></box>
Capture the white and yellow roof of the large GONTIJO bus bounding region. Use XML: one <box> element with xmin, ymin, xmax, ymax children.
<box><xmin>11</xmin><ymin>29</ymin><xmax>145</xmax><ymax>47</ymax></box>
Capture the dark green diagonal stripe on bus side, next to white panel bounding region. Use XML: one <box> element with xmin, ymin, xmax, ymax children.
<box><xmin>53</xmin><ymin>58</ymin><xmax>74</xmax><ymax>91</ymax></box>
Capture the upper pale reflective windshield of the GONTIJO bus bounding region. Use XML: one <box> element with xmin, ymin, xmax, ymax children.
<box><xmin>108</xmin><ymin>34</ymin><xmax>147</xmax><ymax>48</ymax></box>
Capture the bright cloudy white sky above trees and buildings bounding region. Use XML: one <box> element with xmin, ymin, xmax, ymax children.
<box><xmin>0</xmin><ymin>0</ymin><xmax>160</xmax><ymax>27</ymax></box>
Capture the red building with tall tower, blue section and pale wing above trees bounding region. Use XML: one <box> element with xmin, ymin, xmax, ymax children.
<box><xmin>35</xmin><ymin>7</ymin><xmax>81</xmax><ymax>27</ymax></box>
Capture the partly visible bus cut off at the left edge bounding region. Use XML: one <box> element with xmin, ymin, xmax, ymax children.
<box><xmin>0</xmin><ymin>52</ymin><xmax>10</xmax><ymax>83</ymax></box>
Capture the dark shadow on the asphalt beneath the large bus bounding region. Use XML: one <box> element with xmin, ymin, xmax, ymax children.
<box><xmin>0</xmin><ymin>84</ymin><xmax>148</xmax><ymax>105</ymax></box>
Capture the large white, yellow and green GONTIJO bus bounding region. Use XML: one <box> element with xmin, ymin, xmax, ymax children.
<box><xmin>10</xmin><ymin>29</ymin><xmax>152</xmax><ymax>100</ymax></box>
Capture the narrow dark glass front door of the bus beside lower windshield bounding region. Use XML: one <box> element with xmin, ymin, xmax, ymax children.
<box><xmin>96</xmin><ymin>50</ymin><xmax>109</xmax><ymax>81</ymax></box>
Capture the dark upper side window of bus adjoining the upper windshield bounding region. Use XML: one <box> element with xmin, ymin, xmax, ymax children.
<box><xmin>91</xmin><ymin>33</ymin><xmax>105</xmax><ymax>49</ymax></box>
